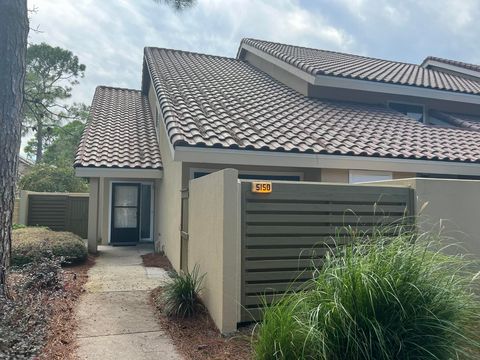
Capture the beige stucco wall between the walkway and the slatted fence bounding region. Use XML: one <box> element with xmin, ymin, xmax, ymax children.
<box><xmin>188</xmin><ymin>169</ymin><xmax>241</xmax><ymax>333</ymax></box>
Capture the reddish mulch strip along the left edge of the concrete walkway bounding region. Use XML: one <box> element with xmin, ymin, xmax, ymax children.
<box><xmin>37</xmin><ymin>256</ymin><xmax>95</xmax><ymax>360</ymax></box>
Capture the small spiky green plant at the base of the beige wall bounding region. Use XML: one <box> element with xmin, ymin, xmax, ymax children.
<box><xmin>161</xmin><ymin>266</ymin><xmax>205</xmax><ymax>318</ymax></box>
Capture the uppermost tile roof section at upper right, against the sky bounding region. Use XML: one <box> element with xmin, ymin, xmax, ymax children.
<box><xmin>242</xmin><ymin>39</ymin><xmax>480</xmax><ymax>95</ymax></box>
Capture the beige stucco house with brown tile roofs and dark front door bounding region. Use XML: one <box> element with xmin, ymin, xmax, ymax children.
<box><xmin>74</xmin><ymin>39</ymin><xmax>480</xmax><ymax>269</ymax></box>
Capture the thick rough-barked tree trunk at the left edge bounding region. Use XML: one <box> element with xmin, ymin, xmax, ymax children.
<box><xmin>0</xmin><ymin>0</ymin><xmax>28</xmax><ymax>295</ymax></box>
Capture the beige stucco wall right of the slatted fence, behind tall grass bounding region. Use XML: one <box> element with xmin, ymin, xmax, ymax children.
<box><xmin>372</xmin><ymin>178</ymin><xmax>480</xmax><ymax>256</ymax></box>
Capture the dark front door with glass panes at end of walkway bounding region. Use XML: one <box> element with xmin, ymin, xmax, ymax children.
<box><xmin>111</xmin><ymin>183</ymin><xmax>140</xmax><ymax>245</ymax></box>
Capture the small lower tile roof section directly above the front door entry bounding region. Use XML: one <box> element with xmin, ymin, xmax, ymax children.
<box><xmin>74</xmin><ymin>86</ymin><xmax>162</xmax><ymax>169</ymax></box>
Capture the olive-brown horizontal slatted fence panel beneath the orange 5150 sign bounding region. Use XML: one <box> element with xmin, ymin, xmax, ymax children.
<box><xmin>241</xmin><ymin>182</ymin><xmax>414</xmax><ymax>322</ymax></box>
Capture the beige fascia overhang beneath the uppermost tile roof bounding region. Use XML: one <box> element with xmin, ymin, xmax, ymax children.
<box><xmin>238</xmin><ymin>43</ymin><xmax>480</xmax><ymax>105</ymax></box>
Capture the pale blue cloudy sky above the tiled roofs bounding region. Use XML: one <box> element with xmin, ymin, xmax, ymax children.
<box><xmin>28</xmin><ymin>0</ymin><xmax>480</xmax><ymax>104</ymax></box>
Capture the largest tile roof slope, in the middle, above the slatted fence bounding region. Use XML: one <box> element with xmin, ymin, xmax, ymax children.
<box><xmin>145</xmin><ymin>48</ymin><xmax>480</xmax><ymax>162</ymax></box>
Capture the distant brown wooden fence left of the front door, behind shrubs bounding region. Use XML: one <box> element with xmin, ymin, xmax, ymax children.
<box><xmin>27</xmin><ymin>193</ymin><xmax>89</xmax><ymax>238</ymax></box>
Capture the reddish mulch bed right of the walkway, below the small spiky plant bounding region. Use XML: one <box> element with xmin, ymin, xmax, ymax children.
<box><xmin>151</xmin><ymin>287</ymin><xmax>252</xmax><ymax>360</ymax></box>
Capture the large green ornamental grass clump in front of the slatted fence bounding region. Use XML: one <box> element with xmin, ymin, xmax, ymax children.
<box><xmin>254</xmin><ymin>229</ymin><xmax>480</xmax><ymax>360</ymax></box>
